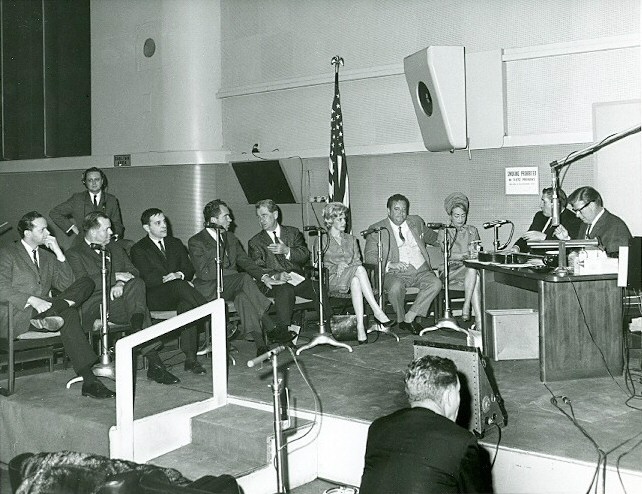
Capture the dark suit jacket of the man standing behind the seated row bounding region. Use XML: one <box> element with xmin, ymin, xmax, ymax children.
<box><xmin>49</xmin><ymin>190</ymin><xmax>125</xmax><ymax>238</ymax></box>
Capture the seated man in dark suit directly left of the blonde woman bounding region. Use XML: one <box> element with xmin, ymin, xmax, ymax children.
<box><xmin>248</xmin><ymin>199</ymin><xmax>330</xmax><ymax>326</ymax></box>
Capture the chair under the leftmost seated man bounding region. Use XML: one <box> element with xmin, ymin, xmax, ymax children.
<box><xmin>0</xmin><ymin>302</ymin><xmax>64</xmax><ymax>396</ymax></box>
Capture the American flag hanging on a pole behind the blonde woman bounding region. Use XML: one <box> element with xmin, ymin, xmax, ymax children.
<box><xmin>328</xmin><ymin>71</ymin><xmax>351</xmax><ymax>232</ymax></box>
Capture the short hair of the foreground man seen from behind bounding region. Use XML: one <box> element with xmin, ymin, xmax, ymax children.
<box><xmin>405</xmin><ymin>355</ymin><xmax>457</xmax><ymax>403</ymax></box>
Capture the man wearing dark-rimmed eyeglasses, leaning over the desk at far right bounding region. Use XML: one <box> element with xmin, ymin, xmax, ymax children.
<box><xmin>555</xmin><ymin>187</ymin><xmax>631</xmax><ymax>257</ymax></box>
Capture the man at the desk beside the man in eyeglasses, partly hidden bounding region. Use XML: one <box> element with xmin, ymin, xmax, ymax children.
<box><xmin>513</xmin><ymin>187</ymin><xmax>581</xmax><ymax>252</ymax></box>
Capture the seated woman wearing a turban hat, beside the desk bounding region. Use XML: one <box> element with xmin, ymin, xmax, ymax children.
<box><xmin>439</xmin><ymin>192</ymin><xmax>483</xmax><ymax>330</ymax></box>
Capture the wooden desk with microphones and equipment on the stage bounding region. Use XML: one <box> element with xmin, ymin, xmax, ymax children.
<box><xmin>466</xmin><ymin>261</ymin><xmax>623</xmax><ymax>382</ymax></box>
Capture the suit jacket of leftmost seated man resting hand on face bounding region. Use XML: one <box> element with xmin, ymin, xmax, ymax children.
<box><xmin>0</xmin><ymin>242</ymin><xmax>74</xmax><ymax>337</ymax></box>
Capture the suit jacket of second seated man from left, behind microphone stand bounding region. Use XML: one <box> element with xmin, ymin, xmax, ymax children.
<box><xmin>66</xmin><ymin>235</ymin><xmax>139</xmax><ymax>328</ymax></box>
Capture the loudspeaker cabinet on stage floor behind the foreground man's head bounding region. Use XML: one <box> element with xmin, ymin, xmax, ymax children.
<box><xmin>414</xmin><ymin>340</ymin><xmax>507</xmax><ymax>437</ymax></box>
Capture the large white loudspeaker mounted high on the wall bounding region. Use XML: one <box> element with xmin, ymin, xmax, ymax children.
<box><xmin>403</xmin><ymin>46</ymin><xmax>467</xmax><ymax>151</ymax></box>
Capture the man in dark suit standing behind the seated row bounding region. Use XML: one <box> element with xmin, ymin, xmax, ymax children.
<box><xmin>49</xmin><ymin>167</ymin><xmax>125</xmax><ymax>238</ymax></box>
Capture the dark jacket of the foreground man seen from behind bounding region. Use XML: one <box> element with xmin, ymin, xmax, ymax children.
<box><xmin>360</xmin><ymin>407</ymin><xmax>492</xmax><ymax>494</ymax></box>
